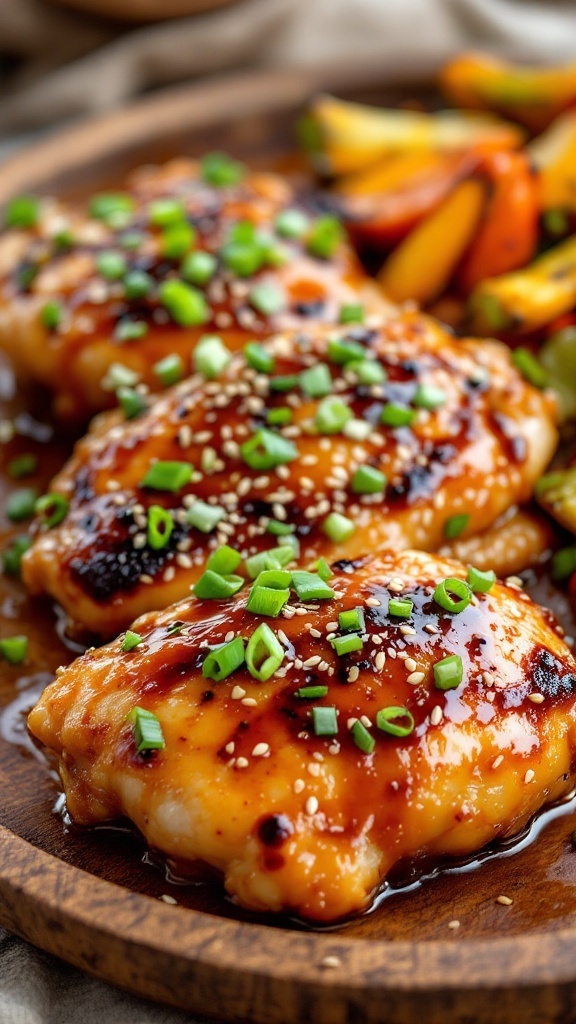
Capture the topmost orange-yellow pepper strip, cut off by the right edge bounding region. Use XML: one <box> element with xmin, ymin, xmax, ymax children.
<box><xmin>440</xmin><ymin>53</ymin><xmax>576</xmax><ymax>131</ymax></box>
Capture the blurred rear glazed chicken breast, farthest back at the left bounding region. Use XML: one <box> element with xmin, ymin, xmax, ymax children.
<box><xmin>0</xmin><ymin>155</ymin><xmax>390</xmax><ymax>420</ymax></box>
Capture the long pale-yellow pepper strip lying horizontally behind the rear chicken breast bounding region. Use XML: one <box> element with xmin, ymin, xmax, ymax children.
<box><xmin>302</xmin><ymin>96</ymin><xmax>524</xmax><ymax>175</ymax></box>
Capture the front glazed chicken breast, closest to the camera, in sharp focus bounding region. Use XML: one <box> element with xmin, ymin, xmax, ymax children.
<box><xmin>29</xmin><ymin>551</ymin><xmax>576</xmax><ymax>922</ymax></box>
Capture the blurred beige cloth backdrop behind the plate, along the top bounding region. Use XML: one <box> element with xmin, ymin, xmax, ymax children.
<box><xmin>0</xmin><ymin>0</ymin><xmax>576</xmax><ymax>135</ymax></box>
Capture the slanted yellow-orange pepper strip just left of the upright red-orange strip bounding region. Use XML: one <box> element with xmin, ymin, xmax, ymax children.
<box><xmin>378</xmin><ymin>178</ymin><xmax>487</xmax><ymax>305</ymax></box>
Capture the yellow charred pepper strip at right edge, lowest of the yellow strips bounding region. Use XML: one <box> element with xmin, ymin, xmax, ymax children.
<box><xmin>467</xmin><ymin>236</ymin><xmax>576</xmax><ymax>335</ymax></box>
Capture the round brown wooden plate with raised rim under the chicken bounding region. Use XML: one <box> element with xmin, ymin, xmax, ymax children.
<box><xmin>0</xmin><ymin>69</ymin><xmax>576</xmax><ymax>1024</ymax></box>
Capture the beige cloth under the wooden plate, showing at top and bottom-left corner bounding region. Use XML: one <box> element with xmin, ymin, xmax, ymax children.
<box><xmin>0</xmin><ymin>0</ymin><xmax>576</xmax><ymax>1024</ymax></box>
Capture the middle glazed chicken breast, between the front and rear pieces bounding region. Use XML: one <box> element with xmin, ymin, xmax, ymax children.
<box><xmin>23</xmin><ymin>313</ymin><xmax>557</xmax><ymax>637</ymax></box>
